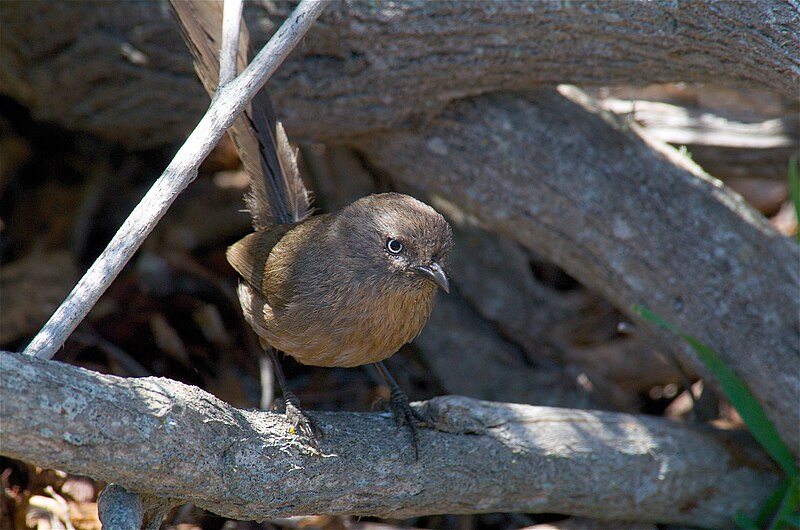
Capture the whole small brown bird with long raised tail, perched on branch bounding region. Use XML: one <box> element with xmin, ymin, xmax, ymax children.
<box><xmin>171</xmin><ymin>0</ymin><xmax>453</xmax><ymax>458</ymax></box>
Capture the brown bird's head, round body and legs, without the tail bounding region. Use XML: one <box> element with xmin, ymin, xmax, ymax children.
<box><xmin>227</xmin><ymin>193</ymin><xmax>453</xmax><ymax>451</ymax></box>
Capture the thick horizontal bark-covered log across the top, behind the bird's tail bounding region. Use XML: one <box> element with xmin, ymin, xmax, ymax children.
<box><xmin>0</xmin><ymin>0</ymin><xmax>800</xmax><ymax>147</ymax></box>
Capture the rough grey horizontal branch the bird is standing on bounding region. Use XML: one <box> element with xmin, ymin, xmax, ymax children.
<box><xmin>0</xmin><ymin>353</ymin><xmax>778</xmax><ymax>527</ymax></box>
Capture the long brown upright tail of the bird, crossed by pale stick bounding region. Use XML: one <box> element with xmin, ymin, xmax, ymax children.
<box><xmin>170</xmin><ymin>0</ymin><xmax>311</xmax><ymax>230</ymax></box>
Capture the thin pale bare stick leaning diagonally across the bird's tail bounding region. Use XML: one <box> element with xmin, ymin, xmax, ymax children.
<box><xmin>24</xmin><ymin>0</ymin><xmax>329</xmax><ymax>359</ymax></box>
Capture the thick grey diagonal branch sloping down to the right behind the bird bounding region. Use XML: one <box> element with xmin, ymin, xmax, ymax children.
<box><xmin>354</xmin><ymin>90</ymin><xmax>800</xmax><ymax>457</ymax></box>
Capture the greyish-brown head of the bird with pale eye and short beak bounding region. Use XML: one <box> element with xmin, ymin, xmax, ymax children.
<box><xmin>341</xmin><ymin>193</ymin><xmax>453</xmax><ymax>292</ymax></box>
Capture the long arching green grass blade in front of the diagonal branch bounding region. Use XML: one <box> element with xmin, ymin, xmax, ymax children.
<box><xmin>633</xmin><ymin>305</ymin><xmax>800</xmax><ymax>479</ymax></box>
